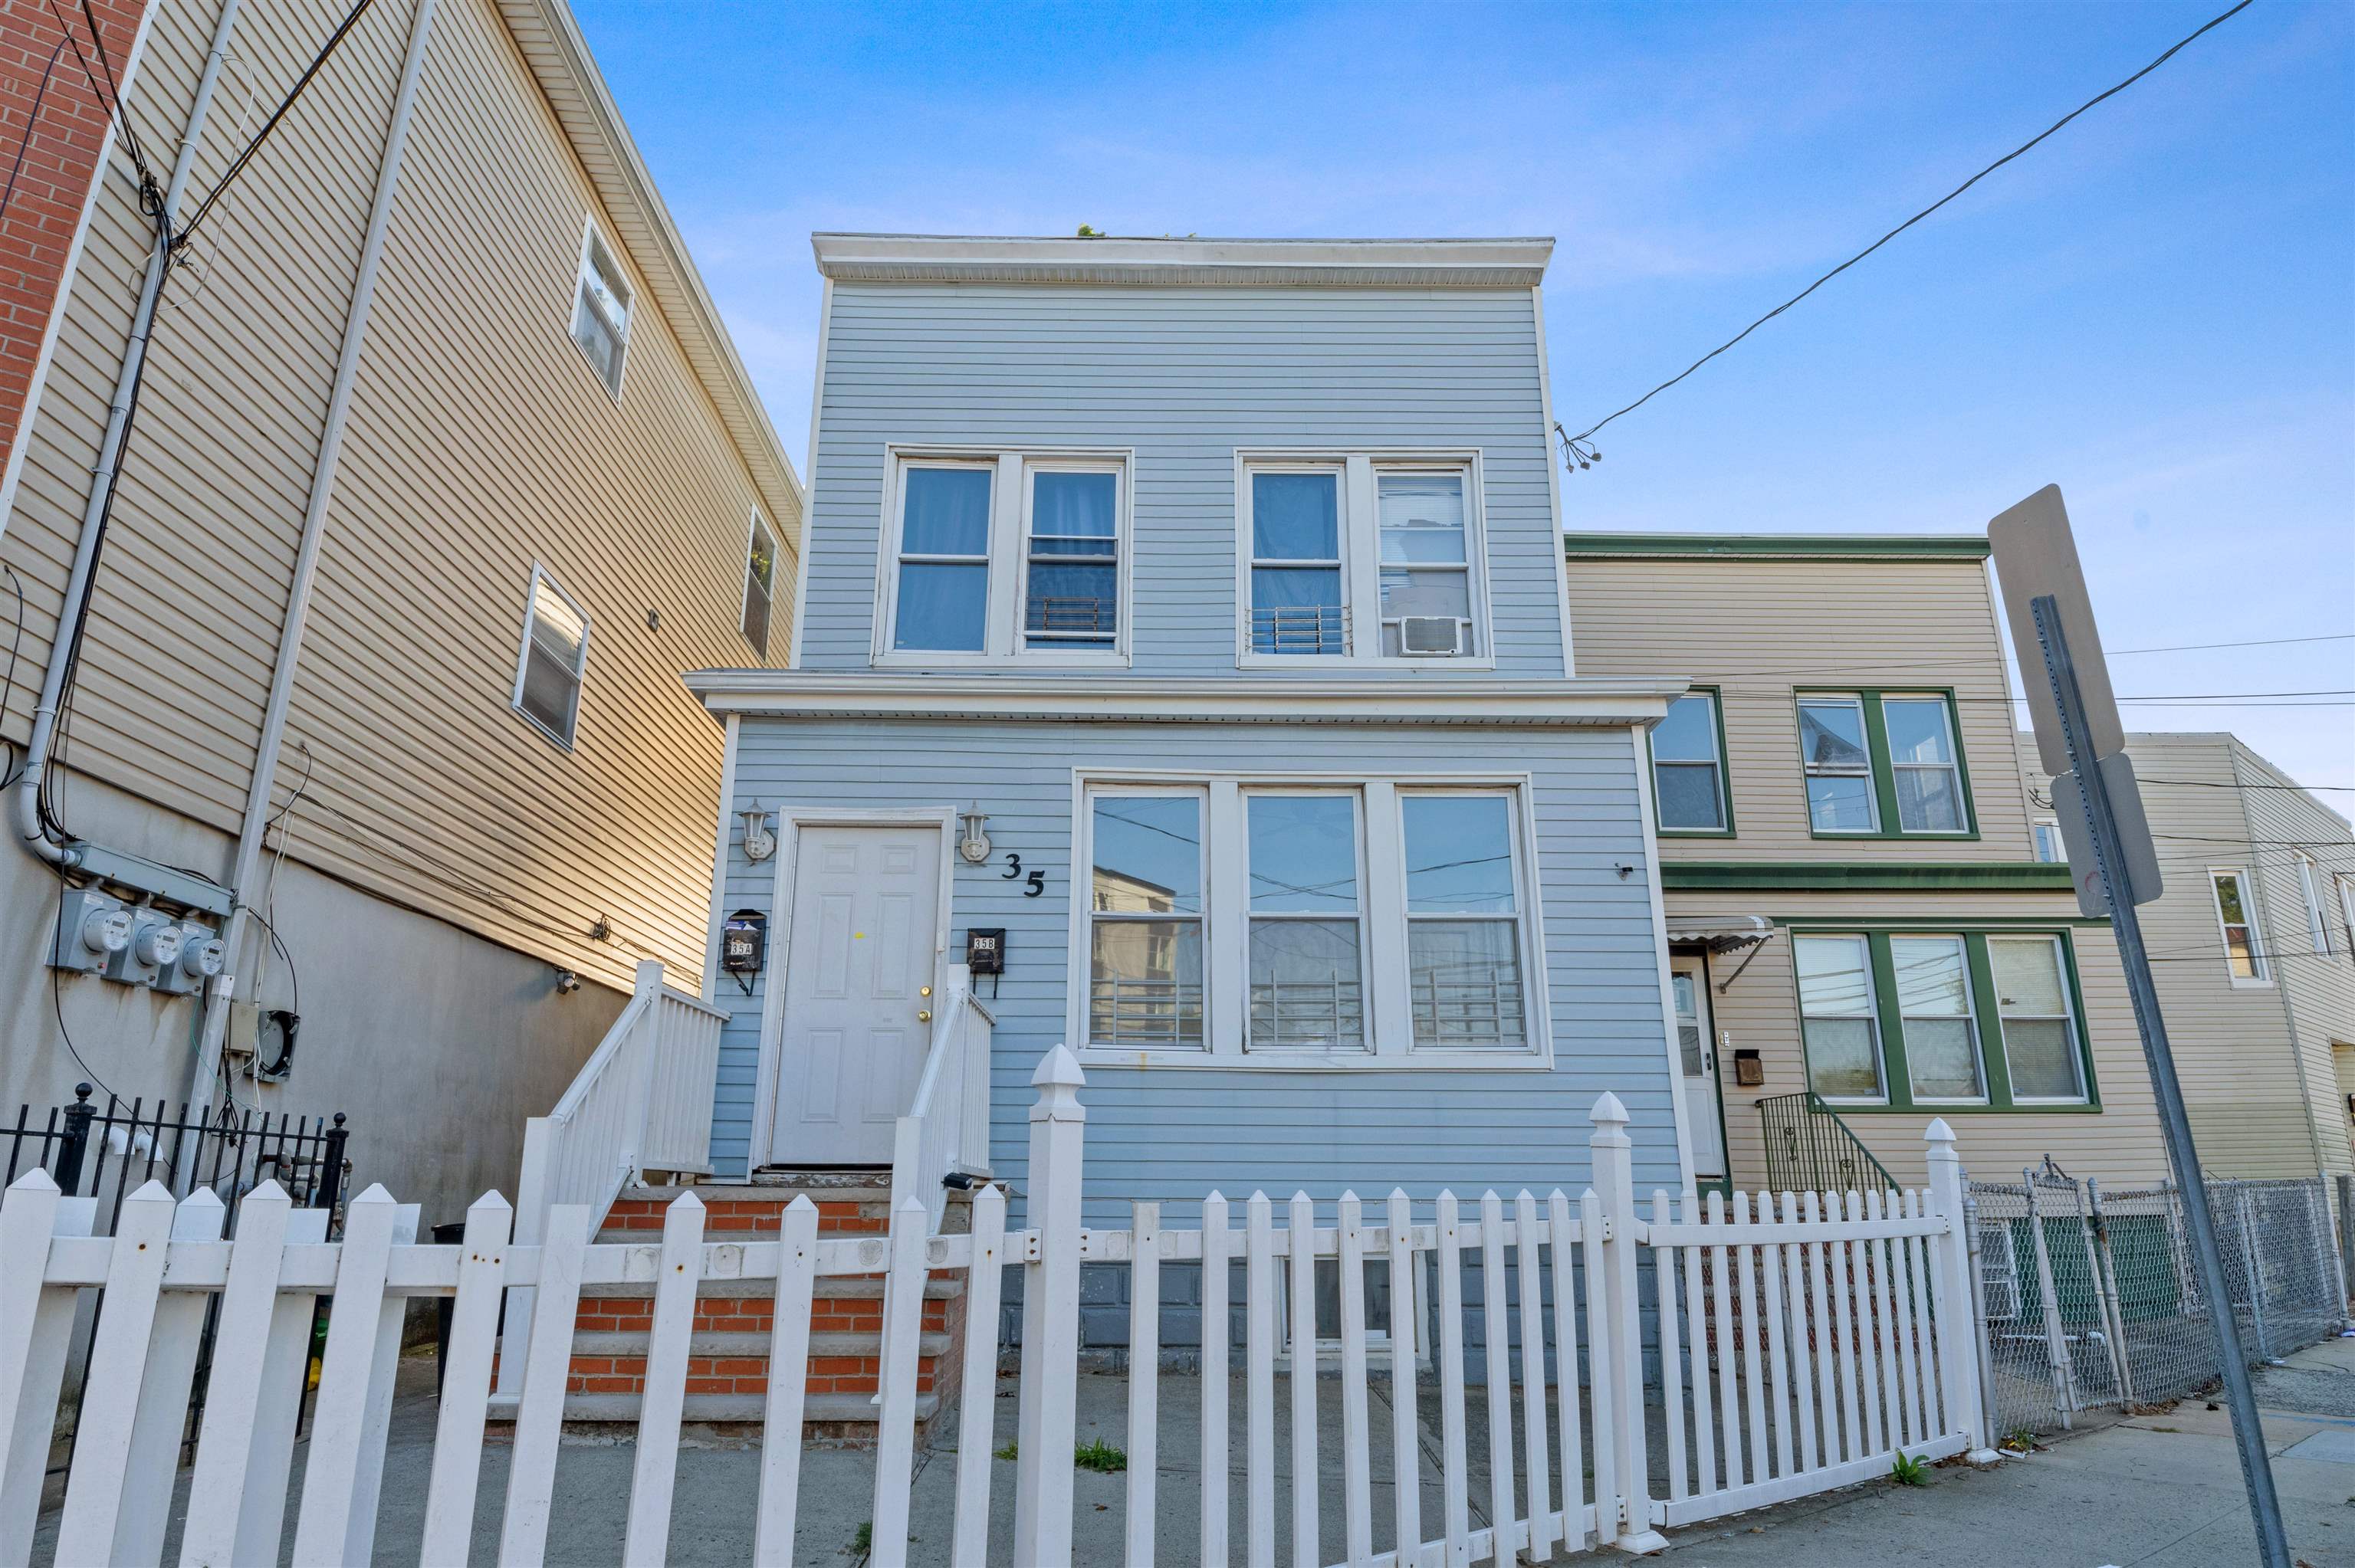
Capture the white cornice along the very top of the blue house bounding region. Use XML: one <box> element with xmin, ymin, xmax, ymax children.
<box><xmin>810</xmin><ymin>233</ymin><xmax>1555</xmax><ymax>290</ymax></box>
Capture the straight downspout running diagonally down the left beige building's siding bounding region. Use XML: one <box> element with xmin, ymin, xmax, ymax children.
<box><xmin>186</xmin><ymin>0</ymin><xmax>435</xmax><ymax>1100</ymax></box>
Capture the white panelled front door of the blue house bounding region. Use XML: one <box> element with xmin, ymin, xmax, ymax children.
<box><xmin>767</xmin><ymin>826</ymin><xmax>940</xmax><ymax>1166</ymax></box>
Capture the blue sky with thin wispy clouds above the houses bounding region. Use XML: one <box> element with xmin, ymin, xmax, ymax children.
<box><xmin>575</xmin><ymin>0</ymin><xmax>2355</xmax><ymax>795</ymax></box>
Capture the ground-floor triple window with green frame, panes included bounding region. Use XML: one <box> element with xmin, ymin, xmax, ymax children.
<box><xmin>1790</xmin><ymin>930</ymin><xmax>2100</xmax><ymax>1111</ymax></box>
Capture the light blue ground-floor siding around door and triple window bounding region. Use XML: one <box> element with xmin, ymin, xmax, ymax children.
<box><xmin>711</xmin><ymin>718</ymin><xmax>1677</xmax><ymax>1215</ymax></box>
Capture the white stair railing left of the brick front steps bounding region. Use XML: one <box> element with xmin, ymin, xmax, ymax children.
<box><xmin>499</xmin><ymin>958</ymin><xmax>725</xmax><ymax>1396</ymax></box>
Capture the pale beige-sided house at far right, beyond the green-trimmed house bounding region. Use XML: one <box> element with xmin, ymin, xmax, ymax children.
<box><xmin>2021</xmin><ymin>734</ymin><xmax>2355</xmax><ymax>1177</ymax></box>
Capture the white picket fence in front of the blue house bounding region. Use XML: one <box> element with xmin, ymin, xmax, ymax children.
<box><xmin>0</xmin><ymin>1048</ymin><xmax>1983</xmax><ymax>1568</ymax></box>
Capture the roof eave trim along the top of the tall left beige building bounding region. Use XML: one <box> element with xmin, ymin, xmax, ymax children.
<box><xmin>497</xmin><ymin>0</ymin><xmax>803</xmax><ymax>532</ymax></box>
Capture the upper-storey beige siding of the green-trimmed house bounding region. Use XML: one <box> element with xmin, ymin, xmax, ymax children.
<box><xmin>1568</xmin><ymin>556</ymin><xmax>2035</xmax><ymax>861</ymax></box>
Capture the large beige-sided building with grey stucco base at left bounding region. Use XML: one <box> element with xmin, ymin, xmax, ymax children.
<box><xmin>0</xmin><ymin>0</ymin><xmax>800</xmax><ymax>1219</ymax></box>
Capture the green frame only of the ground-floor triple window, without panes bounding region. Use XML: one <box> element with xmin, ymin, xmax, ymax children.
<box><xmin>1788</xmin><ymin>923</ymin><xmax>2100</xmax><ymax>1116</ymax></box>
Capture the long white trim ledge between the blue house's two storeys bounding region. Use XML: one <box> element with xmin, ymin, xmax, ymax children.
<box><xmin>685</xmin><ymin>668</ymin><xmax>1689</xmax><ymax>727</ymax></box>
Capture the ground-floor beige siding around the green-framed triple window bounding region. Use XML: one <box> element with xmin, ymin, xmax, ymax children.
<box><xmin>1667</xmin><ymin>892</ymin><xmax>2166</xmax><ymax>1186</ymax></box>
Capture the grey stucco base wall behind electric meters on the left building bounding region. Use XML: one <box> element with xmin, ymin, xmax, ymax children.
<box><xmin>0</xmin><ymin>779</ymin><xmax>622</xmax><ymax>1224</ymax></box>
